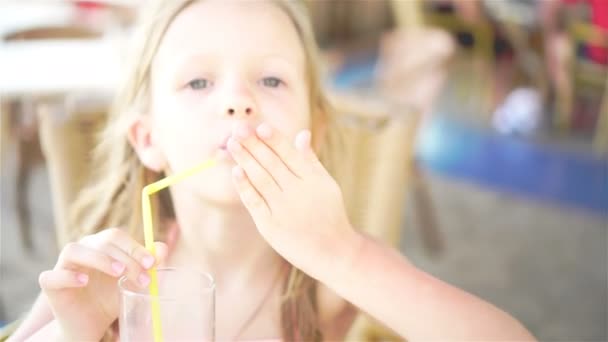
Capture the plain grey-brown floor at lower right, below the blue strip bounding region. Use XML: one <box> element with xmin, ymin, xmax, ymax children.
<box><xmin>402</xmin><ymin>174</ymin><xmax>608</xmax><ymax>341</ymax></box>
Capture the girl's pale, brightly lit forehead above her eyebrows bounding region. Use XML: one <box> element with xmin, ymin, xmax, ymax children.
<box><xmin>156</xmin><ymin>0</ymin><xmax>305</xmax><ymax>72</ymax></box>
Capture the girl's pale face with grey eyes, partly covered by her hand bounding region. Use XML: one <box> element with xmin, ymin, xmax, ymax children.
<box><xmin>130</xmin><ymin>0</ymin><xmax>310</xmax><ymax>205</ymax></box>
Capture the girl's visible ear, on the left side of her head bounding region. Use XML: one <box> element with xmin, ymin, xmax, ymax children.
<box><xmin>127</xmin><ymin>115</ymin><xmax>167</xmax><ymax>172</ymax></box>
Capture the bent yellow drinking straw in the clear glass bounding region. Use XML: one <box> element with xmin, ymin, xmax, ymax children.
<box><xmin>141</xmin><ymin>160</ymin><xmax>215</xmax><ymax>342</ymax></box>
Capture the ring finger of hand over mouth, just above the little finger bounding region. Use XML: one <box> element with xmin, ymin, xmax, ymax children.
<box><xmin>228</xmin><ymin>138</ymin><xmax>281</xmax><ymax>203</ymax></box>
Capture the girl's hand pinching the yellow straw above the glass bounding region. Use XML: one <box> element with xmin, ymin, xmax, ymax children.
<box><xmin>39</xmin><ymin>228</ymin><xmax>167</xmax><ymax>341</ymax></box>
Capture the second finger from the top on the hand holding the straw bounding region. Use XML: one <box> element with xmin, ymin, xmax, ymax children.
<box><xmin>55</xmin><ymin>242</ymin><xmax>122</xmax><ymax>277</ymax></box>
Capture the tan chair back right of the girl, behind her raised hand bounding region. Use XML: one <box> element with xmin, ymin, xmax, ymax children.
<box><xmin>337</xmin><ymin>100</ymin><xmax>422</xmax><ymax>341</ymax></box>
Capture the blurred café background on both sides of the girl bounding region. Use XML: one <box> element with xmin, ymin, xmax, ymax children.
<box><xmin>0</xmin><ymin>0</ymin><xmax>608</xmax><ymax>341</ymax></box>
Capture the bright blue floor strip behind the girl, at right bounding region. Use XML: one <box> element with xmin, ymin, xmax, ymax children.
<box><xmin>332</xmin><ymin>56</ymin><xmax>608</xmax><ymax>216</ymax></box>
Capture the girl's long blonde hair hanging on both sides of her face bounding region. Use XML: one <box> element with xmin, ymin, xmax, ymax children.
<box><xmin>69</xmin><ymin>0</ymin><xmax>350</xmax><ymax>341</ymax></box>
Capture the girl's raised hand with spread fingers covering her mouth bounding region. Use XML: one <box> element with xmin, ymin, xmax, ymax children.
<box><xmin>228</xmin><ymin>124</ymin><xmax>354</xmax><ymax>279</ymax></box>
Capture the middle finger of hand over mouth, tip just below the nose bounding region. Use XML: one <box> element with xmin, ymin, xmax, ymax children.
<box><xmin>237</xmin><ymin>127</ymin><xmax>294</xmax><ymax>189</ymax></box>
